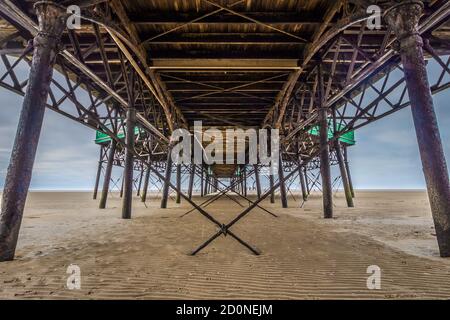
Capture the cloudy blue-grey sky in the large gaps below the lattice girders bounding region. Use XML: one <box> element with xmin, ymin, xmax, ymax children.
<box><xmin>0</xmin><ymin>58</ymin><xmax>450</xmax><ymax>190</ymax></box>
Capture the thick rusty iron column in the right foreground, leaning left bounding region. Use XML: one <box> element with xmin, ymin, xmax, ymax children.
<box><xmin>385</xmin><ymin>1</ymin><xmax>450</xmax><ymax>257</ymax></box>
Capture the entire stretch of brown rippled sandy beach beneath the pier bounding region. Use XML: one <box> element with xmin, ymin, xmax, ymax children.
<box><xmin>0</xmin><ymin>191</ymin><xmax>450</xmax><ymax>299</ymax></box>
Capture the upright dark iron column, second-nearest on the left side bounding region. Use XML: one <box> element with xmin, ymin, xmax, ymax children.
<box><xmin>122</xmin><ymin>107</ymin><xmax>136</xmax><ymax>219</ymax></box>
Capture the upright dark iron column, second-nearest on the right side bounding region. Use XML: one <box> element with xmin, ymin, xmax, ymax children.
<box><xmin>317</xmin><ymin>63</ymin><xmax>333</xmax><ymax>219</ymax></box>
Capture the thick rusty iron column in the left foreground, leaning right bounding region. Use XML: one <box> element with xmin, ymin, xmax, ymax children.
<box><xmin>0</xmin><ymin>1</ymin><xmax>67</xmax><ymax>261</ymax></box>
